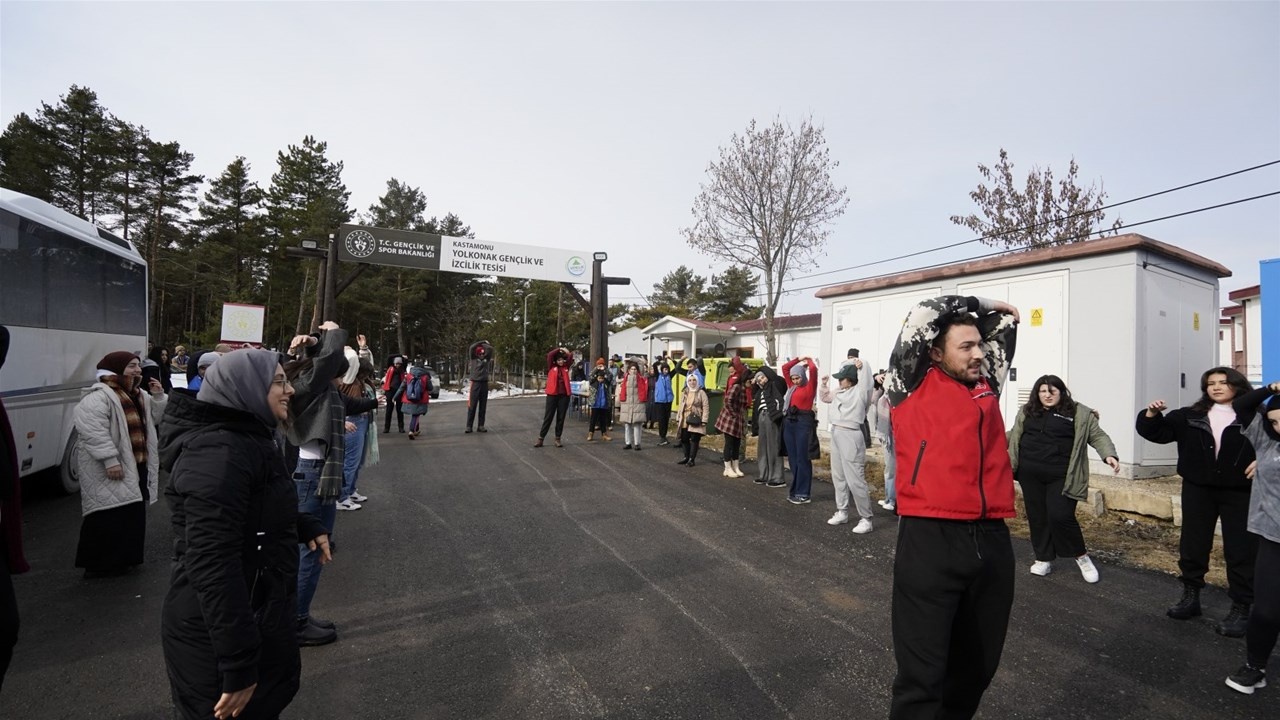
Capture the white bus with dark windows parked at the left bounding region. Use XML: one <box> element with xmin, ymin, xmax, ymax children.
<box><xmin>0</xmin><ymin>188</ymin><xmax>147</xmax><ymax>492</ymax></box>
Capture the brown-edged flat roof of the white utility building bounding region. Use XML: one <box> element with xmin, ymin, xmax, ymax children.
<box><xmin>814</xmin><ymin>233</ymin><xmax>1231</xmax><ymax>297</ymax></box>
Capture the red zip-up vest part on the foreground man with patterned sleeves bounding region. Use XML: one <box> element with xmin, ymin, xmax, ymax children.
<box><xmin>890</xmin><ymin>365</ymin><xmax>1015</xmax><ymax>520</ymax></box>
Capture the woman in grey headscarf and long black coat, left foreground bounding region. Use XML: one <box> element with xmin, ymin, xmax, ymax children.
<box><xmin>160</xmin><ymin>350</ymin><xmax>330</xmax><ymax>720</ymax></box>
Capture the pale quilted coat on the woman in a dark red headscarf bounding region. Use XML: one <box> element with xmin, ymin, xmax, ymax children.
<box><xmin>72</xmin><ymin>383</ymin><xmax>169</xmax><ymax>515</ymax></box>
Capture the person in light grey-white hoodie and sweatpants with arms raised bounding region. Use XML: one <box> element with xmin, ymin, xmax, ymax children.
<box><xmin>818</xmin><ymin>357</ymin><xmax>874</xmax><ymax>534</ymax></box>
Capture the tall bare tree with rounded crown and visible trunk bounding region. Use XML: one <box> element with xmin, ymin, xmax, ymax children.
<box><xmin>681</xmin><ymin>117</ymin><xmax>849</xmax><ymax>364</ymax></box>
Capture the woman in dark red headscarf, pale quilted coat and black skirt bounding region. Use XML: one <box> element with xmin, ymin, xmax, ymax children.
<box><xmin>72</xmin><ymin>351</ymin><xmax>166</xmax><ymax>578</ymax></box>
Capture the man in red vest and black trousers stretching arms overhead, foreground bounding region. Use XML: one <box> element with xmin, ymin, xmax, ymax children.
<box><xmin>884</xmin><ymin>296</ymin><xmax>1018</xmax><ymax>720</ymax></box>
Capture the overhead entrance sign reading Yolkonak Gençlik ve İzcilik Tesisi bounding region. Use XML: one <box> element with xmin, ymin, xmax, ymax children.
<box><xmin>335</xmin><ymin>224</ymin><xmax>591</xmax><ymax>284</ymax></box>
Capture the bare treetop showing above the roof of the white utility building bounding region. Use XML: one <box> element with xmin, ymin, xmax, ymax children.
<box><xmin>951</xmin><ymin>147</ymin><xmax>1124</xmax><ymax>247</ymax></box>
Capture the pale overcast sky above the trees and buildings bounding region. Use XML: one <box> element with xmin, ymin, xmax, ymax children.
<box><xmin>0</xmin><ymin>0</ymin><xmax>1280</xmax><ymax>313</ymax></box>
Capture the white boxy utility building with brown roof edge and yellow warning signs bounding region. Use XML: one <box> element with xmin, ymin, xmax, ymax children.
<box><xmin>817</xmin><ymin>234</ymin><xmax>1231</xmax><ymax>477</ymax></box>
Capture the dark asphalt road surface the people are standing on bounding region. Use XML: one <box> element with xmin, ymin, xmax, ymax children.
<box><xmin>0</xmin><ymin>398</ymin><xmax>1280</xmax><ymax>720</ymax></box>
